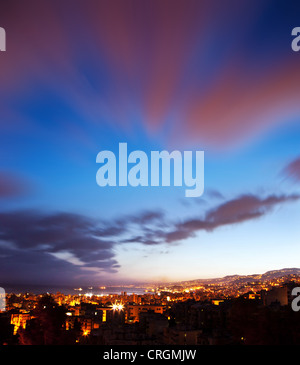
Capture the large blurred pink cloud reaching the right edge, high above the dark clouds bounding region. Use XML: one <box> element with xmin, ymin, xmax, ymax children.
<box><xmin>182</xmin><ymin>60</ymin><xmax>300</xmax><ymax>146</ymax></box>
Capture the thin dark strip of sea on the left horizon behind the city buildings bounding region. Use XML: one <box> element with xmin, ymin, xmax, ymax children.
<box><xmin>2</xmin><ymin>285</ymin><xmax>153</xmax><ymax>296</ymax></box>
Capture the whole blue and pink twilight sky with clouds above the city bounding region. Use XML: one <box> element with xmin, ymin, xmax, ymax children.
<box><xmin>0</xmin><ymin>0</ymin><xmax>300</xmax><ymax>286</ymax></box>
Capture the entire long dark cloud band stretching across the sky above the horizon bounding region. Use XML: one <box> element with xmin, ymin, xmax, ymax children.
<box><xmin>0</xmin><ymin>194</ymin><xmax>300</xmax><ymax>284</ymax></box>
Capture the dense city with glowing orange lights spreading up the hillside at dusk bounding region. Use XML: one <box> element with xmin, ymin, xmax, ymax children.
<box><xmin>0</xmin><ymin>269</ymin><xmax>300</xmax><ymax>345</ymax></box>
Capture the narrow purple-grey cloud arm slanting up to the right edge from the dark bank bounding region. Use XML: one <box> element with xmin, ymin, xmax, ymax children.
<box><xmin>115</xmin><ymin>194</ymin><xmax>300</xmax><ymax>246</ymax></box>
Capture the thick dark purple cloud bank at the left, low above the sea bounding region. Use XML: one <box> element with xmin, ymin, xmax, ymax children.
<box><xmin>0</xmin><ymin>210</ymin><xmax>121</xmax><ymax>283</ymax></box>
